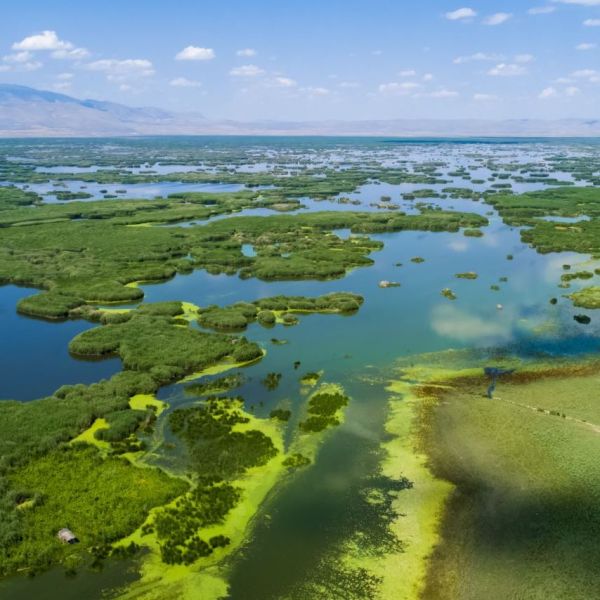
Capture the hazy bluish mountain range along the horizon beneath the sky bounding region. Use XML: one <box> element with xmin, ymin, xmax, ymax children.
<box><xmin>0</xmin><ymin>84</ymin><xmax>600</xmax><ymax>137</ymax></box>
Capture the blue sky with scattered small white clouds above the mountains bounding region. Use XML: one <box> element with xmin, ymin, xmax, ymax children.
<box><xmin>0</xmin><ymin>0</ymin><xmax>600</xmax><ymax>121</ymax></box>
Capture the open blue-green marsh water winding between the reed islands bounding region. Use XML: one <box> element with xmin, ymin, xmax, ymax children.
<box><xmin>0</xmin><ymin>138</ymin><xmax>600</xmax><ymax>600</ymax></box>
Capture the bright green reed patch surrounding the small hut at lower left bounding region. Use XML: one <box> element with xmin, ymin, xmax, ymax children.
<box><xmin>0</xmin><ymin>445</ymin><xmax>188</xmax><ymax>573</ymax></box>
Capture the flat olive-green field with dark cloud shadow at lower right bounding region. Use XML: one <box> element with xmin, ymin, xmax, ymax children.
<box><xmin>422</xmin><ymin>360</ymin><xmax>600</xmax><ymax>600</ymax></box>
